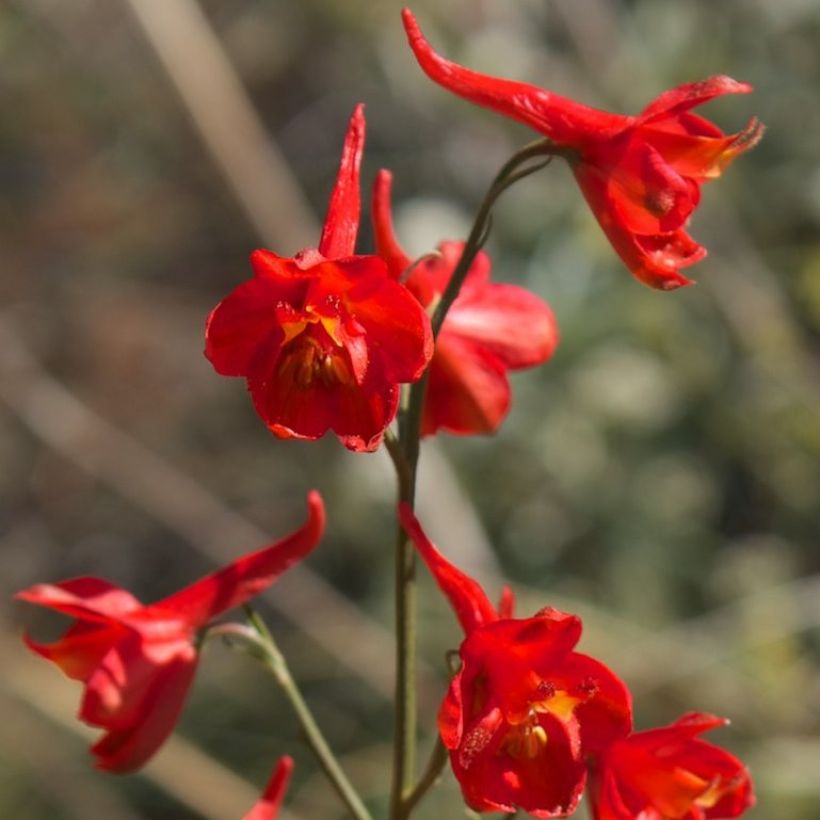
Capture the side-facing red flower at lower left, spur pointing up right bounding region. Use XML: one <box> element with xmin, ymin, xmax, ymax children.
<box><xmin>16</xmin><ymin>492</ymin><xmax>325</xmax><ymax>772</ymax></box>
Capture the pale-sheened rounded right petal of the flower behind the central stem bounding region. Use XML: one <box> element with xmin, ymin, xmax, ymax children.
<box><xmin>442</xmin><ymin>284</ymin><xmax>558</xmax><ymax>369</ymax></box>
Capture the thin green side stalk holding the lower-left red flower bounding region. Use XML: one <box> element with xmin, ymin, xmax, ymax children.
<box><xmin>208</xmin><ymin>620</ymin><xmax>372</xmax><ymax>820</ymax></box>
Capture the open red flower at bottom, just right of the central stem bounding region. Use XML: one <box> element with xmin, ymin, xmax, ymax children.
<box><xmin>400</xmin><ymin>505</ymin><xmax>632</xmax><ymax>817</ymax></box>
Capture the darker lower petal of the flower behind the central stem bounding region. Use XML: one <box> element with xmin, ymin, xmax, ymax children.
<box><xmin>421</xmin><ymin>332</ymin><xmax>510</xmax><ymax>436</ymax></box>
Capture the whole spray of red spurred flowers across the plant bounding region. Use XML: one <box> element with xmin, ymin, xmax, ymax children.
<box><xmin>12</xmin><ymin>10</ymin><xmax>762</xmax><ymax>820</ymax></box>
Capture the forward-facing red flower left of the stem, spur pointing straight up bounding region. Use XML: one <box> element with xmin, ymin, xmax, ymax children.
<box><xmin>205</xmin><ymin>105</ymin><xmax>433</xmax><ymax>451</ymax></box>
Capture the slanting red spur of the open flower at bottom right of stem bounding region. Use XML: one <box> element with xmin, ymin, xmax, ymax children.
<box><xmin>399</xmin><ymin>503</ymin><xmax>498</xmax><ymax>635</ymax></box>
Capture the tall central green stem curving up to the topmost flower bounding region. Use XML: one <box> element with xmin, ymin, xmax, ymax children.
<box><xmin>385</xmin><ymin>139</ymin><xmax>556</xmax><ymax>820</ymax></box>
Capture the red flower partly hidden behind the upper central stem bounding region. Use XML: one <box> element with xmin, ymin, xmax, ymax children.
<box><xmin>372</xmin><ymin>170</ymin><xmax>558</xmax><ymax>436</ymax></box>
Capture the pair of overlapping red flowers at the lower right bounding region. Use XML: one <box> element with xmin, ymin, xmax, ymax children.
<box><xmin>399</xmin><ymin>505</ymin><xmax>754</xmax><ymax>820</ymax></box>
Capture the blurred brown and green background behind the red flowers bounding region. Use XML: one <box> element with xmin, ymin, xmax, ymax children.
<box><xmin>0</xmin><ymin>0</ymin><xmax>820</xmax><ymax>820</ymax></box>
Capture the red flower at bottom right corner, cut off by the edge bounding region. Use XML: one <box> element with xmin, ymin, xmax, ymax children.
<box><xmin>590</xmin><ymin>712</ymin><xmax>754</xmax><ymax>820</ymax></box>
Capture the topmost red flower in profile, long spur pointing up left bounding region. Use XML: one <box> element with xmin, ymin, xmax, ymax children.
<box><xmin>403</xmin><ymin>9</ymin><xmax>763</xmax><ymax>290</ymax></box>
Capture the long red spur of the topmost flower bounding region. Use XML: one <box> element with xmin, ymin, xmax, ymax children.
<box><xmin>402</xmin><ymin>9</ymin><xmax>631</xmax><ymax>147</ymax></box>
